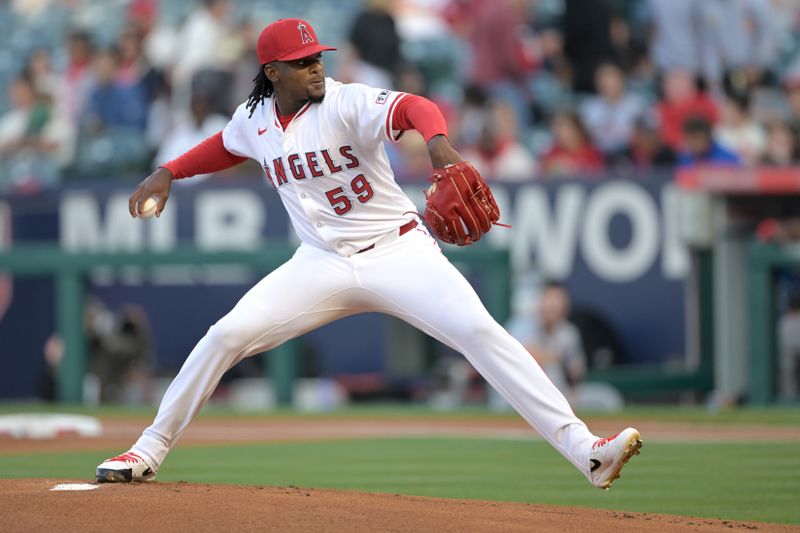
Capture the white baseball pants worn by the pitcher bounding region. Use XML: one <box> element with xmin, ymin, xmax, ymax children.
<box><xmin>133</xmin><ymin>225</ymin><xmax>597</xmax><ymax>479</ymax></box>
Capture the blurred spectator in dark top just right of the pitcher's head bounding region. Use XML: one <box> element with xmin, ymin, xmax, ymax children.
<box><xmin>337</xmin><ymin>0</ymin><xmax>402</xmax><ymax>88</ymax></box>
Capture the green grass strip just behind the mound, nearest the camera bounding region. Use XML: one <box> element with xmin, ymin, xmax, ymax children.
<box><xmin>0</xmin><ymin>437</ymin><xmax>800</xmax><ymax>524</ymax></box>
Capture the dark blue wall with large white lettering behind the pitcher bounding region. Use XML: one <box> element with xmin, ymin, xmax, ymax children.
<box><xmin>0</xmin><ymin>178</ymin><xmax>689</xmax><ymax>397</ymax></box>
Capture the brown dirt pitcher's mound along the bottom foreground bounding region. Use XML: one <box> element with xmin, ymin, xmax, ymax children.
<box><xmin>0</xmin><ymin>479</ymin><xmax>797</xmax><ymax>533</ymax></box>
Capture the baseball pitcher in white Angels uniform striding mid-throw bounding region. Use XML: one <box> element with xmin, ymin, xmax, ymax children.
<box><xmin>96</xmin><ymin>19</ymin><xmax>642</xmax><ymax>489</ymax></box>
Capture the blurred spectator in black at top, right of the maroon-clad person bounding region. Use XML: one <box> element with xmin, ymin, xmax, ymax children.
<box><xmin>563</xmin><ymin>0</ymin><xmax>614</xmax><ymax>93</ymax></box>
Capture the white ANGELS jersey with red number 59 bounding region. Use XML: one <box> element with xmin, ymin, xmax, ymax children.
<box><xmin>222</xmin><ymin>78</ymin><xmax>416</xmax><ymax>256</ymax></box>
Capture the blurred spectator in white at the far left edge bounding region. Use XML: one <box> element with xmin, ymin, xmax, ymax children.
<box><xmin>0</xmin><ymin>75</ymin><xmax>74</xmax><ymax>192</ymax></box>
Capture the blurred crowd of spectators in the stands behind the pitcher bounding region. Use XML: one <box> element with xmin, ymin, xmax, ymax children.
<box><xmin>0</xmin><ymin>0</ymin><xmax>800</xmax><ymax>192</ymax></box>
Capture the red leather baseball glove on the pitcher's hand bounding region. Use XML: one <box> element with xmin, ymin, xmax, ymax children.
<box><xmin>424</xmin><ymin>161</ymin><xmax>500</xmax><ymax>246</ymax></box>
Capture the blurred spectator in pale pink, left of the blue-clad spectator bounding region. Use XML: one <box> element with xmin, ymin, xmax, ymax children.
<box><xmin>56</xmin><ymin>30</ymin><xmax>94</xmax><ymax>124</ymax></box>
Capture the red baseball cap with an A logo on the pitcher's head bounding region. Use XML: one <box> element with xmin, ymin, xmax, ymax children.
<box><xmin>256</xmin><ymin>19</ymin><xmax>336</xmax><ymax>65</ymax></box>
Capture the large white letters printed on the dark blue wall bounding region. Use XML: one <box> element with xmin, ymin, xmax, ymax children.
<box><xmin>59</xmin><ymin>180</ymin><xmax>689</xmax><ymax>283</ymax></box>
